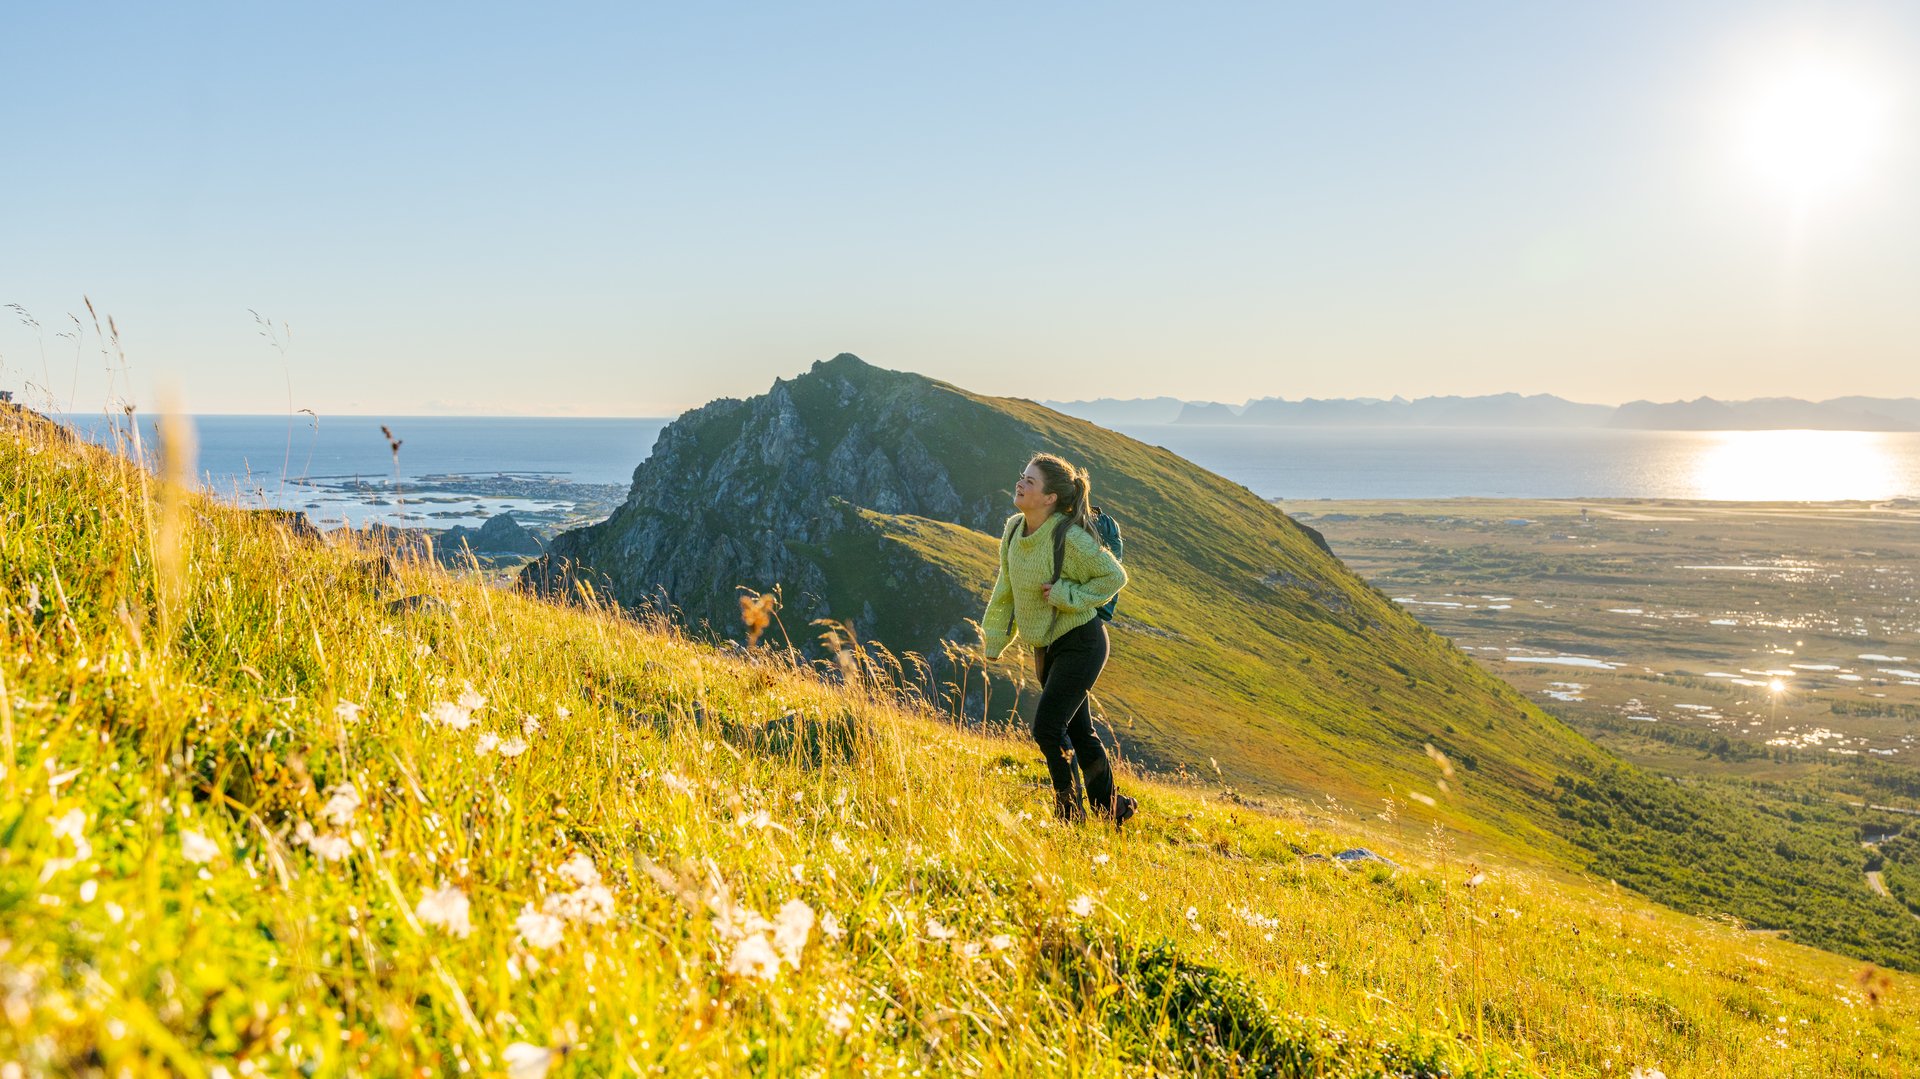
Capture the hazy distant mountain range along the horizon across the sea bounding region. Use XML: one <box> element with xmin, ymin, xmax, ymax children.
<box><xmin>1043</xmin><ymin>394</ymin><xmax>1920</xmax><ymax>430</ymax></box>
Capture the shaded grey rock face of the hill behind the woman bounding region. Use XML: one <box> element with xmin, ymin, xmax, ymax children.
<box><xmin>520</xmin><ymin>355</ymin><xmax>1031</xmax><ymax>647</ymax></box>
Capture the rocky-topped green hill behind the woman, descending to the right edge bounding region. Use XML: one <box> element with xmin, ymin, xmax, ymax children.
<box><xmin>545</xmin><ymin>355</ymin><xmax>1920</xmax><ymax>970</ymax></box>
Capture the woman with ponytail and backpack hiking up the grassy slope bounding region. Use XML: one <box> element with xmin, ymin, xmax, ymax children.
<box><xmin>981</xmin><ymin>453</ymin><xmax>1137</xmax><ymax>826</ymax></box>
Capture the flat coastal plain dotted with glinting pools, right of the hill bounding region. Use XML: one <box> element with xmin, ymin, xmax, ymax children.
<box><xmin>1286</xmin><ymin>499</ymin><xmax>1920</xmax><ymax>776</ymax></box>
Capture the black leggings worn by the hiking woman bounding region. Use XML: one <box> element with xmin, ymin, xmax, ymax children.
<box><xmin>1033</xmin><ymin>618</ymin><xmax>1114</xmax><ymax>820</ymax></box>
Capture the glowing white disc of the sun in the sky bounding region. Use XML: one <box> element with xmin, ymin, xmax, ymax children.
<box><xmin>1738</xmin><ymin>58</ymin><xmax>1893</xmax><ymax>209</ymax></box>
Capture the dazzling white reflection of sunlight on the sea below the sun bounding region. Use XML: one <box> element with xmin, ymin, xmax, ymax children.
<box><xmin>1692</xmin><ymin>430</ymin><xmax>1897</xmax><ymax>501</ymax></box>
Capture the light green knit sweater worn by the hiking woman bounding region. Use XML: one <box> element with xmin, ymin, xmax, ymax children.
<box><xmin>979</xmin><ymin>513</ymin><xmax>1127</xmax><ymax>659</ymax></box>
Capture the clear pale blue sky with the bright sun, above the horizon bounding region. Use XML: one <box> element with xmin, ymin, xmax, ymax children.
<box><xmin>0</xmin><ymin>0</ymin><xmax>1920</xmax><ymax>415</ymax></box>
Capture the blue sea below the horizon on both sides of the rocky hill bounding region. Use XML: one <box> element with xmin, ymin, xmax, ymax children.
<box><xmin>75</xmin><ymin>415</ymin><xmax>1920</xmax><ymax>528</ymax></box>
